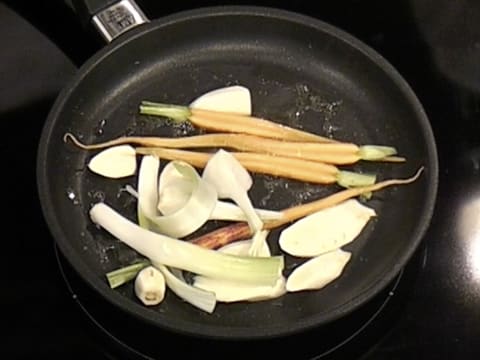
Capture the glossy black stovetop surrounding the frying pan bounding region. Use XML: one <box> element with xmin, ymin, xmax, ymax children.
<box><xmin>0</xmin><ymin>0</ymin><xmax>480</xmax><ymax>359</ymax></box>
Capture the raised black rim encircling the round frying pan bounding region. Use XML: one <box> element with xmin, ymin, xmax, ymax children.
<box><xmin>37</xmin><ymin>5</ymin><xmax>439</xmax><ymax>340</ymax></box>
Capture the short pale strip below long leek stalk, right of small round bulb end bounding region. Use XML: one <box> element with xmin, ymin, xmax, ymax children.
<box><xmin>154</xmin><ymin>263</ymin><xmax>217</xmax><ymax>314</ymax></box>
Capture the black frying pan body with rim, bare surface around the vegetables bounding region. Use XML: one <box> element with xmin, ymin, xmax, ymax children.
<box><xmin>37</xmin><ymin>0</ymin><xmax>438</xmax><ymax>339</ymax></box>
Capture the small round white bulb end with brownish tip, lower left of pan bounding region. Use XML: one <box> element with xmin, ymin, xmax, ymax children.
<box><xmin>134</xmin><ymin>266</ymin><xmax>165</xmax><ymax>306</ymax></box>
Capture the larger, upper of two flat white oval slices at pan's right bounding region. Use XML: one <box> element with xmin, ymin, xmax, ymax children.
<box><xmin>279</xmin><ymin>199</ymin><xmax>376</xmax><ymax>257</ymax></box>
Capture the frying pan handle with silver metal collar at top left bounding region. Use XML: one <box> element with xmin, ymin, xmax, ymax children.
<box><xmin>72</xmin><ymin>0</ymin><xmax>149</xmax><ymax>42</ymax></box>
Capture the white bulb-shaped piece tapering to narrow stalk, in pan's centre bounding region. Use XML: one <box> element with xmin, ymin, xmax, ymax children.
<box><xmin>202</xmin><ymin>149</ymin><xmax>263</xmax><ymax>233</ymax></box>
